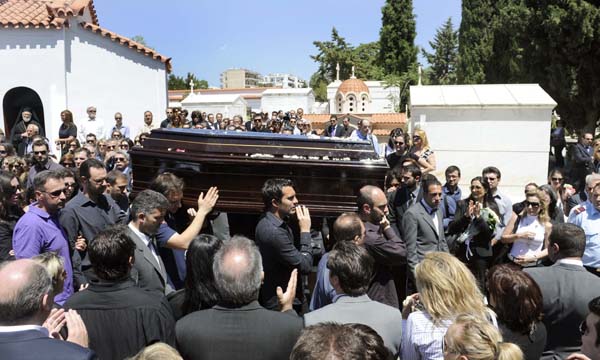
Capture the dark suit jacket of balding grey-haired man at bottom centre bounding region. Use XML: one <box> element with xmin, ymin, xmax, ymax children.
<box><xmin>175</xmin><ymin>301</ymin><xmax>302</xmax><ymax>360</ymax></box>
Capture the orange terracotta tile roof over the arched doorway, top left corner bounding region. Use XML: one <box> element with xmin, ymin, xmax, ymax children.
<box><xmin>0</xmin><ymin>0</ymin><xmax>98</xmax><ymax>29</ymax></box>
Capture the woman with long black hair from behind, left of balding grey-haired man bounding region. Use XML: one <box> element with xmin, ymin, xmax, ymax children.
<box><xmin>169</xmin><ymin>234</ymin><xmax>223</xmax><ymax>320</ymax></box>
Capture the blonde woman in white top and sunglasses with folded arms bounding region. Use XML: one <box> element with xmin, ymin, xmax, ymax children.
<box><xmin>500</xmin><ymin>190</ymin><xmax>552</xmax><ymax>267</ymax></box>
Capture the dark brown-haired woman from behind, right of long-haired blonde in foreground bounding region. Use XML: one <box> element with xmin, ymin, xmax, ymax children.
<box><xmin>488</xmin><ymin>264</ymin><xmax>547</xmax><ymax>360</ymax></box>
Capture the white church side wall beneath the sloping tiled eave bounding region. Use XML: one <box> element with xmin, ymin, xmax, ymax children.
<box><xmin>66</xmin><ymin>26</ymin><xmax>168</xmax><ymax>136</ymax></box>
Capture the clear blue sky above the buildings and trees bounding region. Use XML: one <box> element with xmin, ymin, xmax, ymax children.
<box><xmin>94</xmin><ymin>0</ymin><xmax>461</xmax><ymax>86</ymax></box>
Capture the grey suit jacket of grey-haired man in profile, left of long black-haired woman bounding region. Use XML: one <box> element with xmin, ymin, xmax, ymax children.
<box><xmin>127</xmin><ymin>227</ymin><xmax>173</xmax><ymax>294</ymax></box>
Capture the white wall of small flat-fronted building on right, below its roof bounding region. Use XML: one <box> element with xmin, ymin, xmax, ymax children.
<box><xmin>411</xmin><ymin>106</ymin><xmax>552</xmax><ymax>201</ymax></box>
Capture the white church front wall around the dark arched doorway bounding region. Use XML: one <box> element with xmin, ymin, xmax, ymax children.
<box><xmin>0</xmin><ymin>28</ymin><xmax>67</xmax><ymax>140</ymax></box>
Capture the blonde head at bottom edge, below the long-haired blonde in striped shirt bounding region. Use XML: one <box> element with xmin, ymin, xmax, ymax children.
<box><xmin>443</xmin><ymin>314</ymin><xmax>523</xmax><ymax>360</ymax></box>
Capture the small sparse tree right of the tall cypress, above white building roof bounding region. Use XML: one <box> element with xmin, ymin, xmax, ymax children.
<box><xmin>422</xmin><ymin>18</ymin><xmax>458</xmax><ymax>85</ymax></box>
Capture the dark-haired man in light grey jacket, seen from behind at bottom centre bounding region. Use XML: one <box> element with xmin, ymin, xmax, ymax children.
<box><xmin>304</xmin><ymin>241</ymin><xmax>402</xmax><ymax>354</ymax></box>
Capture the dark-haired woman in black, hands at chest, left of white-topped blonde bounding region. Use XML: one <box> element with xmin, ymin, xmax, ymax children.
<box><xmin>448</xmin><ymin>176</ymin><xmax>500</xmax><ymax>292</ymax></box>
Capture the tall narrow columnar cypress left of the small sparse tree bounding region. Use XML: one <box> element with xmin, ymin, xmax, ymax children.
<box><xmin>379</xmin><ymin>0</ymin><xmax>417</xmax><ymax>76</ymax></box>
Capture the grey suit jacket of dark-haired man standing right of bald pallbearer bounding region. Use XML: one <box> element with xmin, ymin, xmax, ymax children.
<box><xmin>402</xmin><ymin>200</ymin><xmax>448</xmax><ymax>276</ymax></box>
